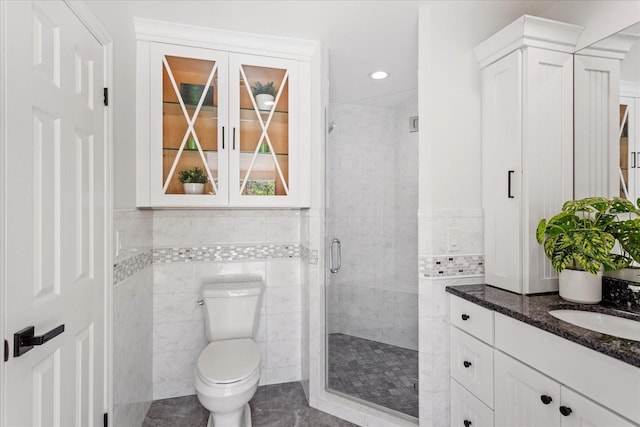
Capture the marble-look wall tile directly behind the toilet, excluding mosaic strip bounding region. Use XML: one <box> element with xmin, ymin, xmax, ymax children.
<box><xmin>153</xmin><ymin>210</ymin><xmax>306</xmax><ymax>399</ymax></box>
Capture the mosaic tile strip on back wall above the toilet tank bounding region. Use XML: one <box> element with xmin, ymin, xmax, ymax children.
<box><xmin>153</xmin><ymin>245</ymin><xmax>302</xmax><ymax>263</ymax></box>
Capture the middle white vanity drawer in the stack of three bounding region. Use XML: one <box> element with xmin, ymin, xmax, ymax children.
<box><xmin>451</xmin><ymin>328</ymin><xmax>493</xmax><ymax>409</ymax></box>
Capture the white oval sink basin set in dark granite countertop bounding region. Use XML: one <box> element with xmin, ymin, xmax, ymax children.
<box><xmin>549</xmin><ymin>310</ymin><xmax>640</xmax><ymax>341</ymax></box>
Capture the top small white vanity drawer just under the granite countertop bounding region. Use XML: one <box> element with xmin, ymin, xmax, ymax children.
<box><xmin>449</xmin><ymin>295</ymin><xmax>493</xmax><ymax>345</ymax></box>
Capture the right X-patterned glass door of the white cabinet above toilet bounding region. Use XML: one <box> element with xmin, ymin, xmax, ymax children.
<box><xmin>229</xmin><ymin>55</ymin><xmax>297</xmax><ymax>204</ymax></box>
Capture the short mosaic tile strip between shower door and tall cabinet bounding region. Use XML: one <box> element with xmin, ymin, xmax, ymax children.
<box><xmin>418</xmin><ymin>255</ymin><xmax>484</xmax><ymax>278</ymax></box>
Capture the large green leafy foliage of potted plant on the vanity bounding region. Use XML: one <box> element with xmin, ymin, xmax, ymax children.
<box><xmin>536</xmin><ymin>197</ymin><xmax>640</xmax><ymax>275</ymax></box>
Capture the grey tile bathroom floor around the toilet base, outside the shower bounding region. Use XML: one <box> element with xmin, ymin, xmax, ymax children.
<box><xmin>143</xmin><ymin>382</ymin><xmax>355</xmax><ymax>427</ymax></box>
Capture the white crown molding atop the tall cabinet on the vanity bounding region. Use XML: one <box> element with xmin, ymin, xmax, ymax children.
<box><xmin>473</xmin><ymin>15</ymin><xmax>584</xmax><ymax>68</ymax></box>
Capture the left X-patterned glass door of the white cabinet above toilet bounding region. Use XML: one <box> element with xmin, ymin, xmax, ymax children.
<box><xmin>151</xmin><ymin>46</ymin><xmax>228</xmax><ymax>203</ymax></box>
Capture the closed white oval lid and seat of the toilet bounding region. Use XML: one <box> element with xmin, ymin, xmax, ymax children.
<box><xmin>196</xmin><ymin>338</ymin><xmax>261</xmax><ymax>386</ymax></box>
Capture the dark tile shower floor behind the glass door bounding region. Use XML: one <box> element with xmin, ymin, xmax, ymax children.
<box><xmin>329</xmin><ymin>334</ymin><xmax>418</xmax><ymax>418</ymax></box>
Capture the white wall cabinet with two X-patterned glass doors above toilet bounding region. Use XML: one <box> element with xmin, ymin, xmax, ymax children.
<box><xmin>136</xmin><ymin>20</ymin><xmax>317</xmax><ymax>208</ymax></box>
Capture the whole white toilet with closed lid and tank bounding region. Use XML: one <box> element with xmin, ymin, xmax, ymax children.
<box><xmin>195</xmin><ymin>276</ymin><xmax>264</xmax><ymax>427</ymax></box>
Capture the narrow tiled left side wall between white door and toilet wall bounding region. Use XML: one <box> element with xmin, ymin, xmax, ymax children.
<box><xmin>113</xmin><ymin>210</ymin><xmax>153</xmax><ymax>426</ymax></box>
